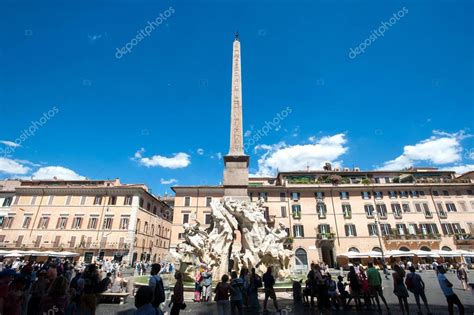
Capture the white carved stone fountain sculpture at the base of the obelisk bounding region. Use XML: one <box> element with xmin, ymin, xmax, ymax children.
<box><xmin>176</xmin><ymin>198</ymin><xmax>293</xmax><ymax>279</ymax></box>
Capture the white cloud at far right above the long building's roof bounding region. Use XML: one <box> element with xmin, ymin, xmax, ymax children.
<box><xmin>379</xmin><ymin>130</ymin><xmax>470</xmax><ymax>170</ymax></box>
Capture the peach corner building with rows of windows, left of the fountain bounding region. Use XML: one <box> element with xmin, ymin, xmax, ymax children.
<box><xmin>0</xmin><ymin>181</ymin><xmax>172</xmax><ymax>262</ymax></box>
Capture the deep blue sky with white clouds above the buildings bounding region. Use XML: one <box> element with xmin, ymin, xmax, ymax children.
<box><xmin>0</xmin><ymin>0</ymin><xmax>474</xmax><ymax>194</ymax></box>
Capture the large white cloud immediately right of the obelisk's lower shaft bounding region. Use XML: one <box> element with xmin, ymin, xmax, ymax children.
<box><xmin>254</xmin><ymin>133</ymin><xmax>348</xmax><ymax>176</ymax></box>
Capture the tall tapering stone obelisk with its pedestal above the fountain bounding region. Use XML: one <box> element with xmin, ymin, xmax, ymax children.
<box><xmin>224</xmin><ymin>33</ymin><xmax>249</xmax><ymax>199</ymax></box>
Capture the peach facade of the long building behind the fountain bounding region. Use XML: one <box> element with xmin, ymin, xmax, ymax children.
<box><xmin>171</xmin><ymin>173</ymin><xmax>474</xmax><ymax>270</ymax></box>
